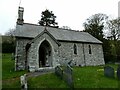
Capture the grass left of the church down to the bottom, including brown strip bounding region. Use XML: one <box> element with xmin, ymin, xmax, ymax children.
<box><xmin>2</xmin><ymin>54</ymin><xmax>27</xmax><ymax>88</ymax></box>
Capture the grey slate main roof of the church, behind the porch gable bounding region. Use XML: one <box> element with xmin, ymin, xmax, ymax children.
<box><xmin>14</xmin><ymin>23</ymin><xmax>102</xmax><ymax>43</ymax></box>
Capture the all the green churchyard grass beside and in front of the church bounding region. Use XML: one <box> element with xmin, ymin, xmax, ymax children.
<box><xmin>2</xmin><ymin>54</ymin><xmax>120</xmax><ymax>89</ymax></box>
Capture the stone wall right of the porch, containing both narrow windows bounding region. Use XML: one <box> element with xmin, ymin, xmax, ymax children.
<box><xmin>59</xmin><ymin>42</ymin><xmax>104</xmax><ymax>66</ymax></box>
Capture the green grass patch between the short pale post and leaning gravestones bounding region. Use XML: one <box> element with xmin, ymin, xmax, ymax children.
<box><xmin>28</xmin><ymin>73</ymin><xmax>69</xmax><ymax>88</ymax></box>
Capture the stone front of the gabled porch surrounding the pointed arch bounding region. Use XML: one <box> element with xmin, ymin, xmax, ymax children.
<box><xmin>27</xmin><ymin>33</ymin><xmax>59</xmax><ymax>71</ymax></box>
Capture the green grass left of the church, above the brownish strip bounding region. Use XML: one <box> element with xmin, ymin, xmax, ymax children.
<box><xmin>2</xmin><ymin>54</ymin><xmax>26</xmax><ymax>80</ymax></box>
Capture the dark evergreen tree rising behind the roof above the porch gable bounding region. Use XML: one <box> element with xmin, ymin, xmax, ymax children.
<box><xmin>38</xmin><ymin>9</ymin><xmax>58</xmax><ymax>27</ymax></box>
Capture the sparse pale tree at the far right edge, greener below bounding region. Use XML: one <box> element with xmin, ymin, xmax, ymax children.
<box><xmin>107</xmin><ymin>18</ymin><xmax>120</xmax><ymax>61</ymax></box>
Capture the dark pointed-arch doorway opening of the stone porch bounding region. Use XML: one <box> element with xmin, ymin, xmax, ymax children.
<box><xmin>39</xmin><ymin>40</ymin><xmax>52</xmax><ymax>68</ymax></box>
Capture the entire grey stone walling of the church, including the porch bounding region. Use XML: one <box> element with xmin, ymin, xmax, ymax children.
<box><xmin>15</xmin><ymin>37</ymin><xmax>105</xmax><ymax>71</ymax></box>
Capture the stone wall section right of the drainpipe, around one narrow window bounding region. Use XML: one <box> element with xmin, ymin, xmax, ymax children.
<box><xmin>84</xmin><ymin>44</ymin><xmax>105</xmax><ymax>66</ymax></box>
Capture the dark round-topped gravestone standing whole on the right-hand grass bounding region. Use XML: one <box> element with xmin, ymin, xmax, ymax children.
<box><xmin>104</xmin><ymin>66</ymin><xmax>115</xmax><ymax>78</ymax></box>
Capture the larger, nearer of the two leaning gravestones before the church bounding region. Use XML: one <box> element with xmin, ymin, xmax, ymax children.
<box><xmin>63</xmin><ymin>65</ymin><xmax>74</xmax><ymax>88</ymax></box>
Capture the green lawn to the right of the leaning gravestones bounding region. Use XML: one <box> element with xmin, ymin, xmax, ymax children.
<box><xmin>74</xmin><ymin>66</ymin><xmax>118</xmax><ymax>88</ymax></box>
